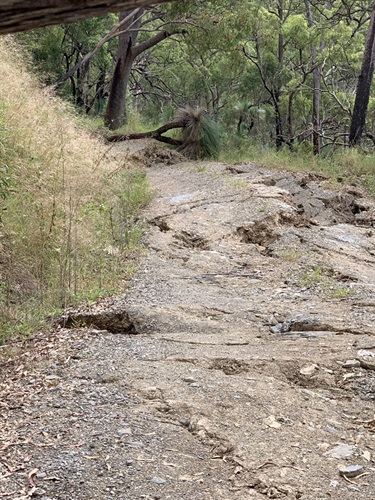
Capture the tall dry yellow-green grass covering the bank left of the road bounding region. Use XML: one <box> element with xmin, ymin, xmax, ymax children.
<box><xmin>0</xmin><ymin>37</ymin><xmax>151</xmax><ymax>342</ymax></box>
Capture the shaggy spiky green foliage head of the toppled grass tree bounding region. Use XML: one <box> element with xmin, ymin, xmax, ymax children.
<box><xmin>175</xmin><ymin>106</ymin><xmax>220</xmax><ymax>159</ymax></box>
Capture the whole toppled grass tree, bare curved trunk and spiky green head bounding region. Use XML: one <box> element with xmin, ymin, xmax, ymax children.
<box><xmin>107</xmin><ymin>107</ymin><xmax>220</xmax><ymax>158</ymax></box>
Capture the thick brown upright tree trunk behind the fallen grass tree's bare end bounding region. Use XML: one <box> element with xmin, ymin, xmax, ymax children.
<box><xmin>104</xmin><ymin>9</ymin><xmax>144</xmax><ymax>130</ymax></box>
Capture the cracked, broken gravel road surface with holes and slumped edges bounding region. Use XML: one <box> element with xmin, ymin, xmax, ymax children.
<box><xmin>0</xmin><ymin>146</ymin><xmax>375</xmax><ymax>500</ymax></box>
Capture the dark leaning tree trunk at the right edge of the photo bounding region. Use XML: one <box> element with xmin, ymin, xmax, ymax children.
<box><xmin>349</xmin><ymin>0</ymin><xmax>375</xmax><ymax>146</ymax></box>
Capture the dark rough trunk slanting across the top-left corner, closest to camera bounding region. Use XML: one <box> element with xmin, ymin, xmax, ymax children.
<box><xmin>0</xmin><ymin>0</ymin><xmax>170</xmax><ymax>35</ymax></box>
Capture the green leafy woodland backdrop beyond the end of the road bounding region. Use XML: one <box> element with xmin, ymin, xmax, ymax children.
<box><xmin>13</xmin><ymin>0</ymin><xmax>375</xmax><ymax>154</ymax></box>
